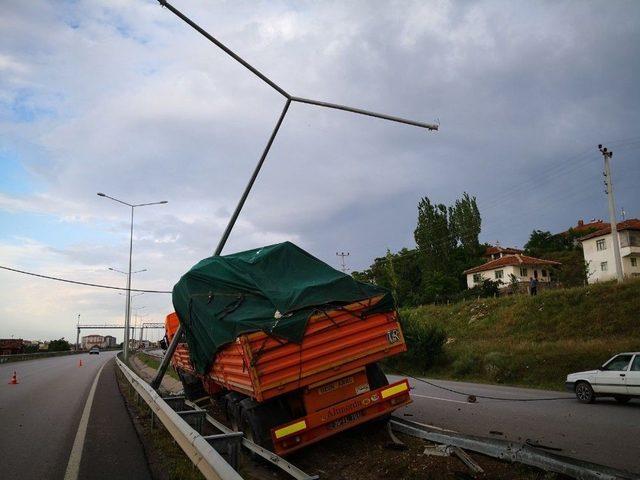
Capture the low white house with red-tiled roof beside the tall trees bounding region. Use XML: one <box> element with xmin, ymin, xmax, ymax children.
<box><xmin>464</xmin><ymin>253</ymin><xmax>560</xmax><ymax>288</ymax></box>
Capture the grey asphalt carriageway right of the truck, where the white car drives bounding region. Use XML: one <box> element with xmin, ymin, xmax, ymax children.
<box><xmin>388</xmin><ymin>375</ymin><xmax>640</xmax><ymax>474</ymax></box>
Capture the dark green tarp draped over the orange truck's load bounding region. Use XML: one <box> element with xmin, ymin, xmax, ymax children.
<box><xmin>173</xmin><ymin>242</ymin><xmax>394</xmax><ymax>373</ymax></box>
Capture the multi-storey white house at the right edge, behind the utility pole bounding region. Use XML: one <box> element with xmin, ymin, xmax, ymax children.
<box><xmin>580</xmin><ymin>218</ymin><xmax>640</xmax><ymax>283</ymax></box>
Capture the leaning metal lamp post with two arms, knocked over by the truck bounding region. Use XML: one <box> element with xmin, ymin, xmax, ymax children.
<box><xmin>151</xmin><ymin>0</ymin><xmax>439</xmax><ymax>389</ymax></box>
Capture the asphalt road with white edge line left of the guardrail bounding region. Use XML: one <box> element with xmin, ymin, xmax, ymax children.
<box><xmin>0</xmin><ymin>352</ymin><xmax>147</xmax><ymax>480</ymax></box>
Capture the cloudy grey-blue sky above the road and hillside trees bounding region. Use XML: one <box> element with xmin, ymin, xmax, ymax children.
<box><xmin>0</xmin><ymin>0</ymin><xmax>640</xmax><ymax>339</ymax></box>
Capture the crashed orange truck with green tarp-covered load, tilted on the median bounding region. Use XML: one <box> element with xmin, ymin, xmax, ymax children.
<box><xmin>165</xmin><ymin>242</ymin><xmax>411</xmax><ymax>455</ymax></box>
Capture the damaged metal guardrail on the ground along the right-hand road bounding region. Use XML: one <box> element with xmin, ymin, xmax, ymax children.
<box><xmin>390</xmin><ymin>416</ymin><xmax>638</xmax><ymax>480</ymax></box>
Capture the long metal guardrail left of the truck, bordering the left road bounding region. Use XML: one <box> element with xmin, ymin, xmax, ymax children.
<box><xmin>116</xmin><ymin>358</ymin><xmax>242</xmax><ymax>480</ymax></box>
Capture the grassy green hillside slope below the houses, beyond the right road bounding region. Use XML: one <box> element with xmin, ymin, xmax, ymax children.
<box><xmin>389</xmin><ymin>281</ymin><xmax>640</xmax><ymax>389</ymax></box>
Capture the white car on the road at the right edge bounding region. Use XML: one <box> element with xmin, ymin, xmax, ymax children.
<box><xmin>565</xmin><ymin>352</ymin><xmax>640</xmax><ymax>403</ymax></box>
